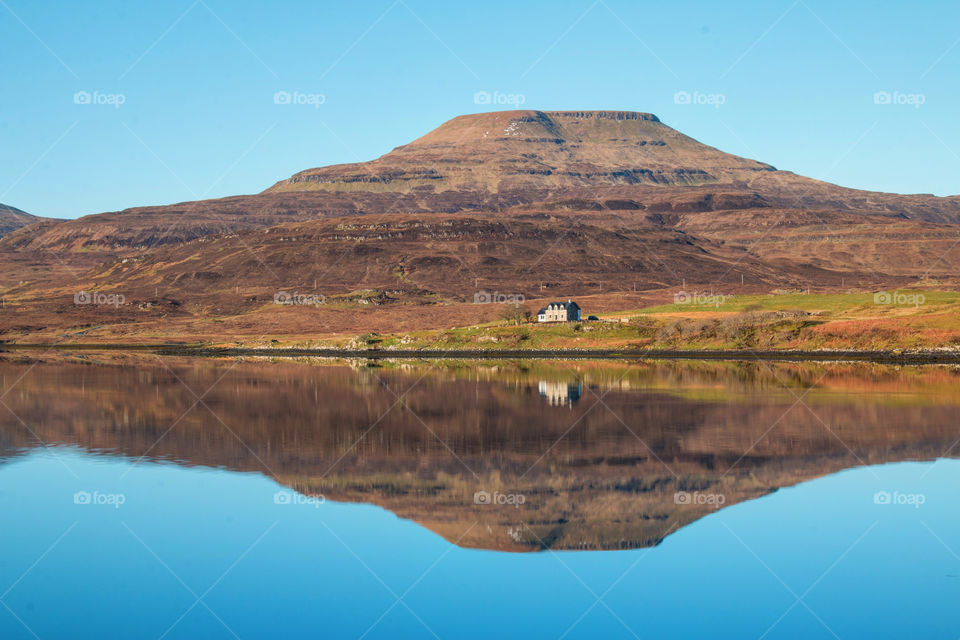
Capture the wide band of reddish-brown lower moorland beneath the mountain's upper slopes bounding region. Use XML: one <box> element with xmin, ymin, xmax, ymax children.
<box><xmin>0</xmin><ymin>207</ymin><xmax>960</xmax><ymax>342</ymax></box>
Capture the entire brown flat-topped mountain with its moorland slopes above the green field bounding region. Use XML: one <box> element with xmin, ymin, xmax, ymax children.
<box><xmin>0</xmin><ymin>111</ymin><xmax>960</xmax><ymax>340</ymax></box>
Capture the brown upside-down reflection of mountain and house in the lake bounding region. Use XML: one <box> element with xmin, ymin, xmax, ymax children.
<box><xmin>0</xmin><ymin>354</ymin><xmax>960</xmax><ymax>551</ymax></box>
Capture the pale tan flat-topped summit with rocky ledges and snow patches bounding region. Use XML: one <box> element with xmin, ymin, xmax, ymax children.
<box><xmin>267</xmin><ymin>111</ymin><xmax>774</xmax><ymax>192</ymax></box>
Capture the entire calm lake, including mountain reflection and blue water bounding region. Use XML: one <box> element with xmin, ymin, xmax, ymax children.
<box><xmin>0</xmin><ymin>353</ymin><xmax>960</xmax><ymax>640</ymax></box>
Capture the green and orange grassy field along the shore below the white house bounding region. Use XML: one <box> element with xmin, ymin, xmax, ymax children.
<box><xmin>291</xmin><ymin>290</ymin><xmax>960</xmax><ymax>351</ymax></box>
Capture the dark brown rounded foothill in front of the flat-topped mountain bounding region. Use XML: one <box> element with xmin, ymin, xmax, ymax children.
<box><xmin>60</xmin><ymin>214</ymin><xmax>784</xmax><ymax>310</ymax></box>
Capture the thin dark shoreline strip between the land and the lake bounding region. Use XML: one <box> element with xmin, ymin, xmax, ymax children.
<box><xmin>0</xmin><ymin>343</ymin><xmax>960</xmax><ymax>365</ymax></box>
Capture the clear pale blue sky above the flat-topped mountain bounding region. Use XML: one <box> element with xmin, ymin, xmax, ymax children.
<box><xmin>0</xmin><ymin>0</ymin><xmax>960</xmax><ymax>217</ymax></box>
